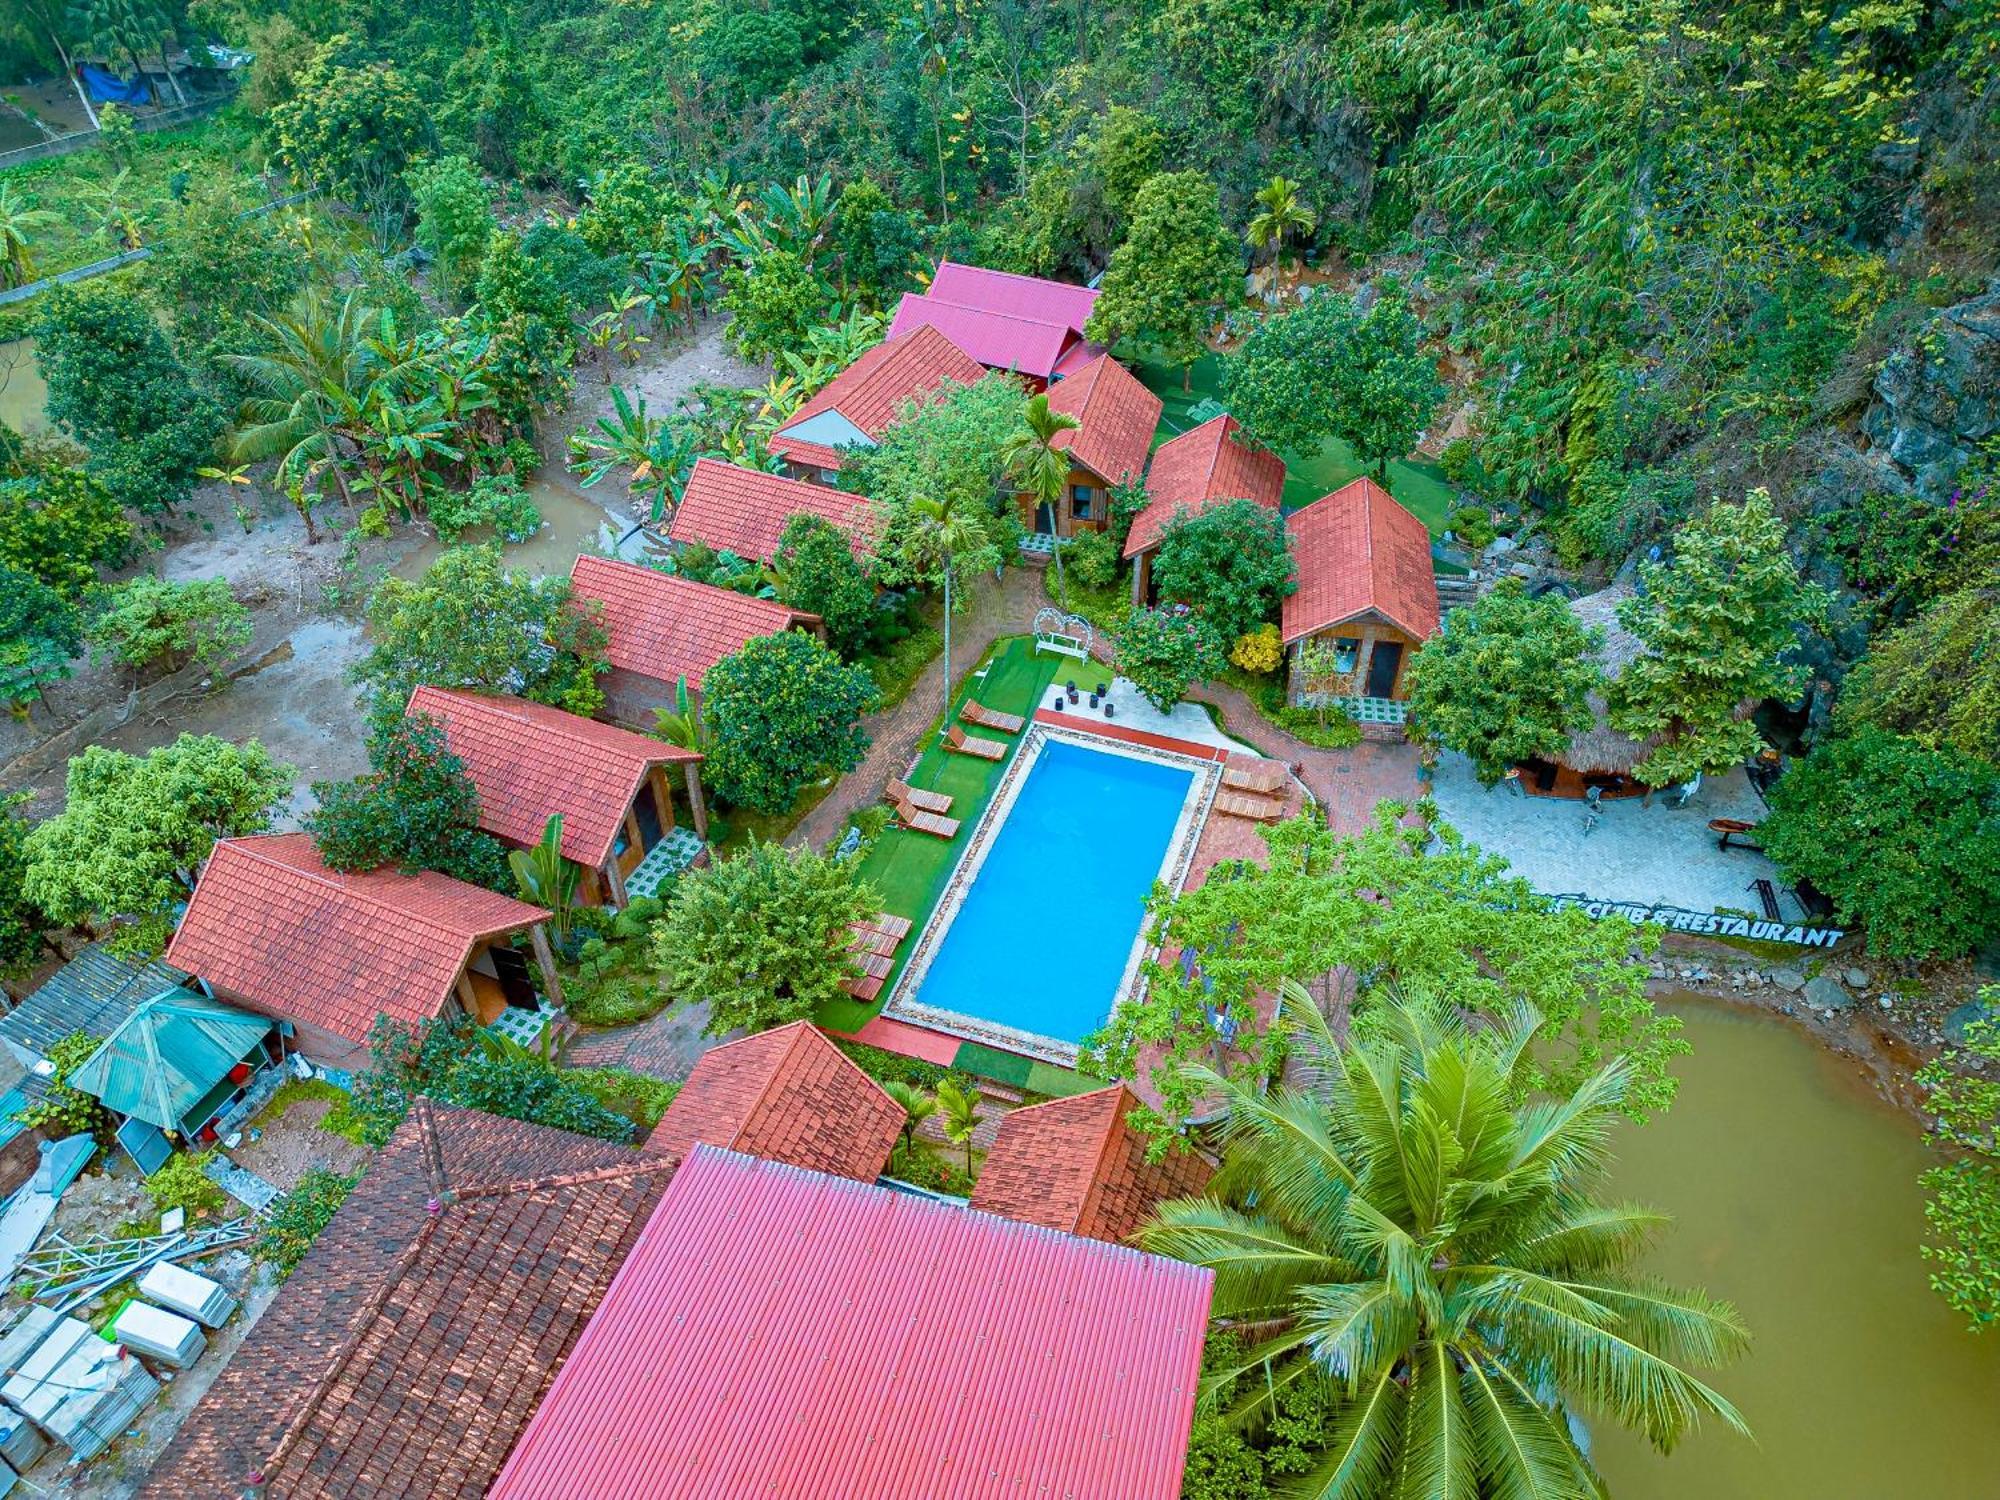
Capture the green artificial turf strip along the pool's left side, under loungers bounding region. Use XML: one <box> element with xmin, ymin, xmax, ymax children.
<box><xmin>814</xmin><ymin>636</ymin><xmax>1082</xmax><ymax>1034</ymax></box>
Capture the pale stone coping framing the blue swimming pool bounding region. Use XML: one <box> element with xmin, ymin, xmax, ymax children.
<box><xmin>882</xmin><ymin>724</ymin><xmax>1222</xmax><ymax>1068</ymax></box>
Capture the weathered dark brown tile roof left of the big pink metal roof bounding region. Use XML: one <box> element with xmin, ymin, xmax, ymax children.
<box><xmin>140</xmin><ymin>1100</ymin><xmax>674</xmax><ymax>1500</ymax></box>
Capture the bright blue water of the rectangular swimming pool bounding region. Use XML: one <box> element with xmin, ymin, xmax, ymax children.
<box><xmin>916</xmin><ymin>740</ymin><xmax>1194</xmax><ymax>1044</ymax></box>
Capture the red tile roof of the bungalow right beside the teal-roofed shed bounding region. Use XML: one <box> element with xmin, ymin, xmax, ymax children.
<box><xmin>166</xmin><ymin>834</ymin><xmax>548</xmax><ymax>1042</ymax></box>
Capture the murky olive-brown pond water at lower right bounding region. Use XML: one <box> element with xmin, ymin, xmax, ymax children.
<box><xmin>1598</xmin><ymin>996</ymin><xmax>2000</xmax><ymax>1500</ymax></box>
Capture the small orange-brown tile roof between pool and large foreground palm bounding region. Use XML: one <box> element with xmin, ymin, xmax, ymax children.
<box><xmin>972</xmin><ymin>1084</ymin><xmax>1212</xmax><ymax>1242</ymax></box>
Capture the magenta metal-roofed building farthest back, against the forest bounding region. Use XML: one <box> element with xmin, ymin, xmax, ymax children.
<box><xmin>888</xmin><ymin>260</ymin><xmax>1104</xmax><ymax>390</ymax></box>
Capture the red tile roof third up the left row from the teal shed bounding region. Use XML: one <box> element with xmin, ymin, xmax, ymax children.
<box><xmin>570</xmin><ymin>556</ymin><xmax>818</xmax><ymax>692</ymax></box>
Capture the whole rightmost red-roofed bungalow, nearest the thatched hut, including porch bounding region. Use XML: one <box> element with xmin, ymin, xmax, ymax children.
<box><xmin>1280</xmin><ymin>478</ymin><xmax>1438</xmax><ymax>722</ymax></box>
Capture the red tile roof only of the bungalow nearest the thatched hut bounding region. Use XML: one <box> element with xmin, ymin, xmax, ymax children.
<box><xmin>1282</xmin><ymin>478</ymin><xmax>1438</xmax><ymax>644</ymax></box>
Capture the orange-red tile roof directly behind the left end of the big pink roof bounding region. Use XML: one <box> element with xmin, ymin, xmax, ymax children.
<box><xmin>646</xmin><ymin>1020</ymin><xmax>906</xmax><ymax>1182</ymax></box>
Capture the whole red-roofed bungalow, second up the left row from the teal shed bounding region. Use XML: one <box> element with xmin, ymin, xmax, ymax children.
<box><xmin>410</xmin><ymin>686</ymin><xmax>708</xmax><ymax>906</ymax></box>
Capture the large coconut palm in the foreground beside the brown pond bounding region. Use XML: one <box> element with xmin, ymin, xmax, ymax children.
<box><xmin>1138</xmin><ymin>986</ymin><xmax>1748</xmax><ymax>1500</ymax></box>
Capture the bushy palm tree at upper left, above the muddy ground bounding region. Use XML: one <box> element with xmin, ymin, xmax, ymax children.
<box><xmin>222</xmin><ymin>290</ymin><xmax>378</xmax><ymax>510</ymax></box>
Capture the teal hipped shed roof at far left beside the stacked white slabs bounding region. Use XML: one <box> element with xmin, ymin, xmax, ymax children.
<box><xmin>70</xmin><ymin>990</ymin><xmax>276</xmax><ymax>1130</ymax></box>
